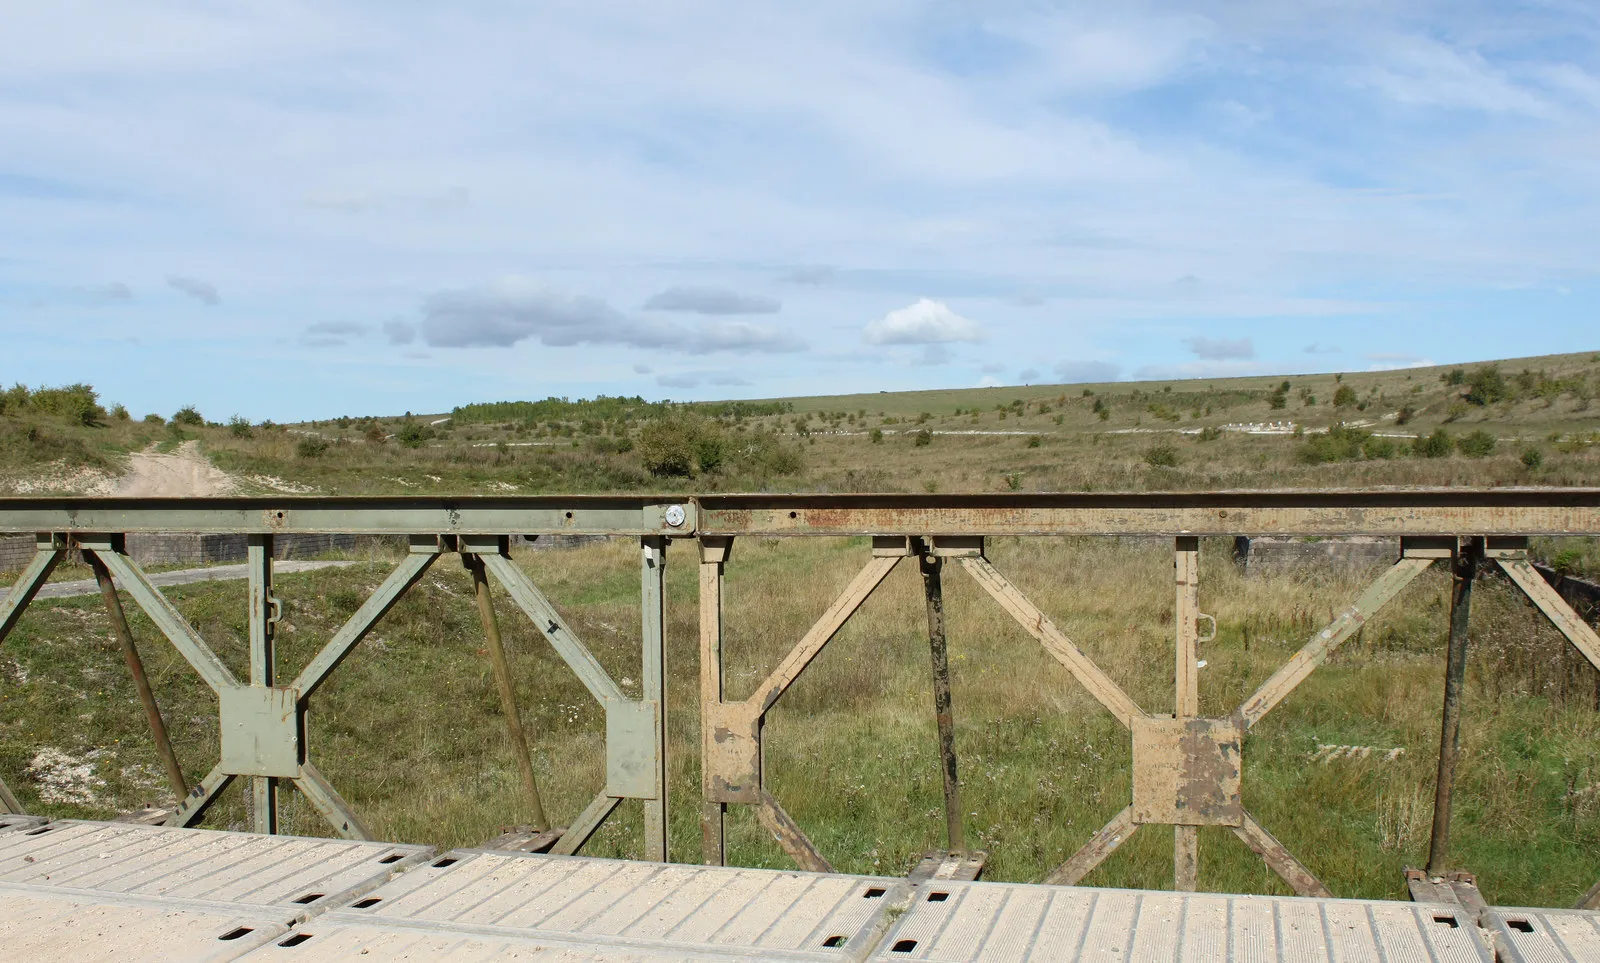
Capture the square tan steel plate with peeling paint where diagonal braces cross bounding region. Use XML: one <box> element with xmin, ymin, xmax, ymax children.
<box><xmin>1133</xmin><ymin>718</ymin><xmax>1245</xmax><ymax>825</ymax></box>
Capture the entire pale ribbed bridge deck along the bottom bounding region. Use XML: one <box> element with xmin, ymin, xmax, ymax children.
<box><xmin>0</xmin><ymin>816</ymin><xmax>1600</xmax><ymax>963</ymax></box>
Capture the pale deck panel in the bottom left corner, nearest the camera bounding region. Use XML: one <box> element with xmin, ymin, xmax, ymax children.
<box><xmin>0</xmin><ymin>883</ymin><xmax>288</xmax><ymax>963</ymax></box>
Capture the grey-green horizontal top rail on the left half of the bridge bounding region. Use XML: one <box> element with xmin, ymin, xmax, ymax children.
<box><xmin>0</xmin><ymin>496</ymin><xmax>694</xmax><ymax>534</ymax></box>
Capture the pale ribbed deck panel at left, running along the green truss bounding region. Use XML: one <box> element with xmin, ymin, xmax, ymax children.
<box><xmin>0</xmin><ymin>819</ymin><xmax>434</xmax><ymax>921</ymax></box>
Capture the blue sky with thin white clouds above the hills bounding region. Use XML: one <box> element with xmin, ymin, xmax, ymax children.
<box><xmin>0</xmin><ymin>0</ymin><xmax>1600</xmax><ymax>421</ymax></box>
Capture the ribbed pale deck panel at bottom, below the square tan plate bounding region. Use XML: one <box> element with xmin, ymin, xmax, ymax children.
<box><xmin>872</xmin><ymin>881</ymin><xmax>1491</xmax><ymax>963</ymax></box>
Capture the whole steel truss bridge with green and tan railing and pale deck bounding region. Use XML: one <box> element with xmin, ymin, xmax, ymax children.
<box><xmin>0</xmin><ymin>489</ymin><xmax>1600</xmax><ymax>963</ymax></box>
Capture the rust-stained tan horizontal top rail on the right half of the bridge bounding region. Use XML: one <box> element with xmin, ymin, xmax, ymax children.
<box><xmin>694</xmin><ymin>488</ymin><xmax>1600</xmax><ymax>536</ymax></box>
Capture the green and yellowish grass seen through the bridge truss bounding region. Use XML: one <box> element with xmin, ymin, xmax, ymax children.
<box><xmin>0</xmin><ymin>539</ymin><xmax>1600</xmax><ymax>905</ymax></box>
